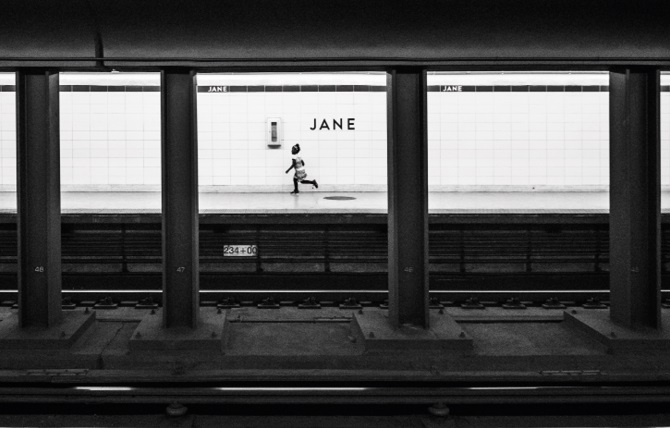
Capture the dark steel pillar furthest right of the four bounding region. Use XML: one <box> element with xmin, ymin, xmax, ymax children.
<box><xmin>610</xmin><ymin>68</ymin><xmax>661</xmax><ymax>329</ymax></box>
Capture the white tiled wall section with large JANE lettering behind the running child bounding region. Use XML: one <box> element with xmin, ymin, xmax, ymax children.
<box><xmin>198</xmin><ymin>74</ymin><xmax>387</xmax><ymax>191</ymax></box>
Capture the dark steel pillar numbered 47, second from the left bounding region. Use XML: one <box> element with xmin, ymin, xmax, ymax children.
<box><xmin>161</xmin><ymin>69</ymin><xmax>199</xmax><ymax>328</ymax></box>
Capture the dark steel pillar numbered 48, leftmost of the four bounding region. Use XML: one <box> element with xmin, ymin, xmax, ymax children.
<box><xmin>16</xmin><ymin>70</ymin><xmax>62</xmax><ymax>328</ymax></box>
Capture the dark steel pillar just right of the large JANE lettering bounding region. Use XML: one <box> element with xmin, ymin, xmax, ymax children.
<box><xmin>387</xmin><ymin>68</ymin><xmax>429</xmax><ymax>329</ymax></box>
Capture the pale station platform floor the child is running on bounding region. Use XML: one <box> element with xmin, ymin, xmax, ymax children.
<box><xmin>0</xmin><ymin>190</ymin><xmax>636</xmax><ymax>214</ymax></box>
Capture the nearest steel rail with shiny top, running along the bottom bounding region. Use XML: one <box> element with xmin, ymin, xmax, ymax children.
<box><xmin>0</xmin><ymin>385</ymin><xmax>670</xmax><ymax>405</ymax></box>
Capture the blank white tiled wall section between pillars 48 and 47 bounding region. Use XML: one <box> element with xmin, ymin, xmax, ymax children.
<box><xmin>60</xmin><ymin>73</ymin><xmax>161</xmax><ymax>191</ymax></box>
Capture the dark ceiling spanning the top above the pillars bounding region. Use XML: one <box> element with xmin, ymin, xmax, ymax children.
<box><xmin>0</xmin><ymin>0</ymin><xmax>670</xmax><ymax>66</ymax></box>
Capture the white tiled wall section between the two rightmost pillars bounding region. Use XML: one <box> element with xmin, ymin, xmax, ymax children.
<box><xmin>428</xmin><ymin>73</ymin><xmax>609</xmax><ymax>190</ymax></box>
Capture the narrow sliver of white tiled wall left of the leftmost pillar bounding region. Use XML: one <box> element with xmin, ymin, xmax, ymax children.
<box><xmin>0</xmin><ymin>73</ymin><xmax>16</xmax><ymax>191</ymax></box>
